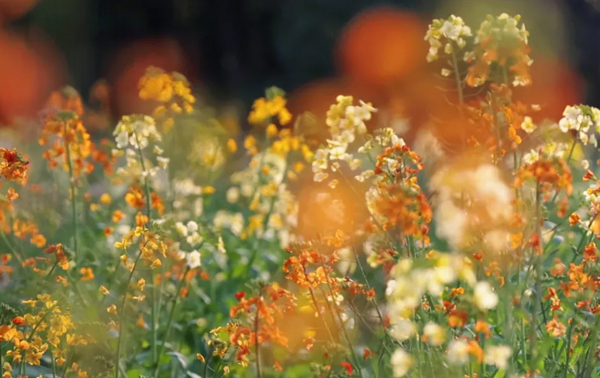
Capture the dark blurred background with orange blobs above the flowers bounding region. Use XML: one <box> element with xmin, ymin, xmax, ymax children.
<box><xmin>0</xmin><ymin>0</ymin><xmax>600</xmax><ymax>130</ymax></box>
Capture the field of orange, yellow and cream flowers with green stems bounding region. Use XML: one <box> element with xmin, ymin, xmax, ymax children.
<box><xmin>0</xmin><ymin>10</ymin><xmax>600</xmax><ymax>378</ymax></box>
